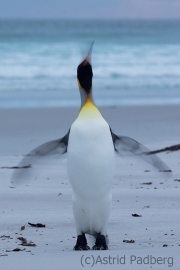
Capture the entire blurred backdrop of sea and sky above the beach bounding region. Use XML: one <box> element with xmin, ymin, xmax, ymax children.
<box><xmin>0</xmin><ymin>0</ymin><xmax>180</xmax><ymax>108</ymax></box>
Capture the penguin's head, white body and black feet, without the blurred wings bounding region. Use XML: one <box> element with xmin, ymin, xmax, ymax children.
<box><xmin>67</xmin><ymin>43</ymin><xmax>115</xmax><ymax>250</ymax></box>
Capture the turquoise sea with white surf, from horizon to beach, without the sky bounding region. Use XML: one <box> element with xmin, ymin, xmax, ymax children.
<box><xmin>0</xmin><ymin>20</ymin><xmax>180</xmax><ymax>108</ymax></box>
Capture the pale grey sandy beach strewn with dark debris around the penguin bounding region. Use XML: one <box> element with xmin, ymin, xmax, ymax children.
<box><xmin>0</xmin><ymin>105</ymin><xmax>180</xmax><ymax>270</ymax></box>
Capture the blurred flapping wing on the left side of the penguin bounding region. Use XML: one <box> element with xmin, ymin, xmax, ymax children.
<box><xmin>11</xmin><ymin>130</ymin><xmax>70</xmax><ymax>184</ymax></box>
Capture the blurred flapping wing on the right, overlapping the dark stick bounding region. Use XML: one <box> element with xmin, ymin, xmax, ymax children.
<box><xmin>110</xmin><ymin>129</ymin><xmax>171</xmax><ymax>172</ymax></box>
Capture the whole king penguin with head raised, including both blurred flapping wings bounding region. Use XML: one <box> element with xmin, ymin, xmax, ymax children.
<box><xmin>11</xmin><ymin>44</ymin><xmax>169</xmax><ymax>250</ymax></box>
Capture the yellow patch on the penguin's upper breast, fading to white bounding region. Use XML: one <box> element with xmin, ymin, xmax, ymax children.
<box><xmin>78</xmin><ymin>95</ymin><xmax>102</xmax><ymax>119</ymax></box>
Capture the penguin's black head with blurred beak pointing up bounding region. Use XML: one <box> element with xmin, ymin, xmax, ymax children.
<box><xmin>77</xmin><ymin>42</ymin><xmax>94</xmax><ymax>94</ymax></box>
